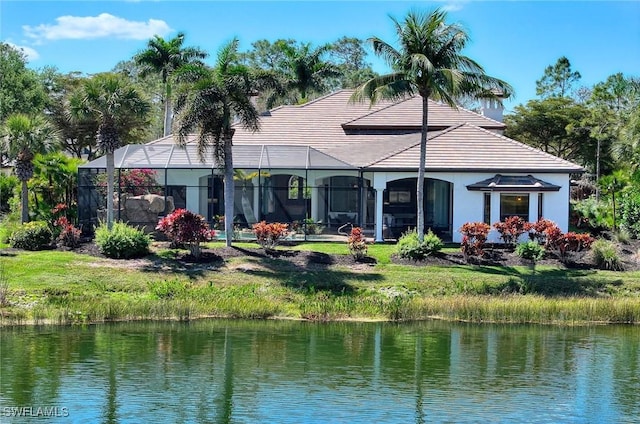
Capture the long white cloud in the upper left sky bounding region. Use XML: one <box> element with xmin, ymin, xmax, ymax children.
<box><xmin>22</xmin><ymin>13</ymin><xmax>172</xmax><ymax>43</ymax></box>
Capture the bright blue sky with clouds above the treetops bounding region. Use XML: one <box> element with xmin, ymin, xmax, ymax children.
<box><xmin>0</xmin><ymin>0</ymin><xmax>640</xmax><ymax>110</ymax></box>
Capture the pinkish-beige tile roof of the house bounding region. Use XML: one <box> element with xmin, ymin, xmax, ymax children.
<box><xmin>141</xmin><ymin>90</ymin><xmax>584</xmax><ymax>173</ymax></box>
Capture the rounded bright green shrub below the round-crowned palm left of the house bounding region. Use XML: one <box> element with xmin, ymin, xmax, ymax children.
<box><xmin>96</xmin><ymin>222</ymin><xmax>151</xmax><ymax>259</ymax></box>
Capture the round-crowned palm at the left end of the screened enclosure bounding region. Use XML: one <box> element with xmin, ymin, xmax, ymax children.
<box><xmin>69</xmin><ymin>73</ymin><xmax>150</xmax><ymax>229</ymax></box>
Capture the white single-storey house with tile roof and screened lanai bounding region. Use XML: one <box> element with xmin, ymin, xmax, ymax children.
<box><xmin>79</xmin><ymin>90</ymin><xmax>584</xmax><ymax>242</ymax></box>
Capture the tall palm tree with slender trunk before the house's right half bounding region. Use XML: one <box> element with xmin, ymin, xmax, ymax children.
<box><xmin>350</xmin><ymin>9</ymin><xmax>513</xmax><ymax>241</ymax></box>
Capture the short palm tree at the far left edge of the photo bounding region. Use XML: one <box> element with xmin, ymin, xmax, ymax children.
<box><xmin>2</xmin><ymin>113</ymin><xmax>58</xmax><ymax>223</ymax></box>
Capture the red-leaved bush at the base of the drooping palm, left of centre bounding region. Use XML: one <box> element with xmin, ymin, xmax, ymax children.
<box><xmin>156</xmin><ymin>209</ymin><xmax>216</xmax><ymax>258</ymax></box>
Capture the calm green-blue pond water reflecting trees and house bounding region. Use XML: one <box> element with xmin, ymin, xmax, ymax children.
<box><xmin>0</xmin><ymin>320</ymin><xmax>640</xmax><ymax>423</ymax></box>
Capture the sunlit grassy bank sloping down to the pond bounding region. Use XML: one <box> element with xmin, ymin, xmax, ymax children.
<box><xmin>0</xmin><ymin>243</ymin><xmax>640</xmax><ymax>325</ymax></box>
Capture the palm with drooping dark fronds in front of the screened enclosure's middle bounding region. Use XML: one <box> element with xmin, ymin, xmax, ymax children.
<box><xmin>175</xmin><ymin>38</ymin><xmax>259</xmax><ymax>246</ymax></box>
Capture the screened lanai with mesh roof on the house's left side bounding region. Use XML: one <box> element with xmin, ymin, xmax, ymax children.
<box><xmin>78</xmin><ymin>143</ymin><xmax>375</xmax><ymax>239</ymax></box>
